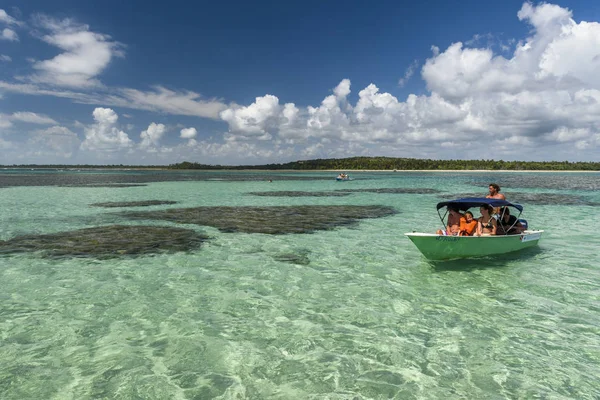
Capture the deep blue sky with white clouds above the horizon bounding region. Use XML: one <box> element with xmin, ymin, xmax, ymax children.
<box><xmin>0</xmin><ymin>0</ymin><xmax>600</xmax><ymax>164</ymax></box>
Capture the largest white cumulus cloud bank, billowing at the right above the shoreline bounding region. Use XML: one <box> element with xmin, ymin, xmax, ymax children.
<box><xmin>220</xmin><ymin>3</ymin><xmax>600</xmax><ymax>159</ymax></box>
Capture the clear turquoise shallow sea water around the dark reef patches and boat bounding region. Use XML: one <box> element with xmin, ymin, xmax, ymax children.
<box><xmin>0</xmin><ymin>171</ymin><xmax>600</xmax><ymax>399</ymax></box>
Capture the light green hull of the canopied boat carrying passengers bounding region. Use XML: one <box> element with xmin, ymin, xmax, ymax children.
<box><xmin>405</xmin><ymin>231</ymin><xmax>544</xmax><ymax>261</ymax></box>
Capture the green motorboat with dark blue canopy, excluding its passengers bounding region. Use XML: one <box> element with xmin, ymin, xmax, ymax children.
<box><xmin>405</xmin><ymin>197</ymin><xmax>544</xmax><ymax>261</ymax></box>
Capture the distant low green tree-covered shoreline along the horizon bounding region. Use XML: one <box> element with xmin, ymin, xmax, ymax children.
<box><xmin>0</xmin><ymin>157</ymin><xmax>600</xmax><ymax>171</ymax></box>
